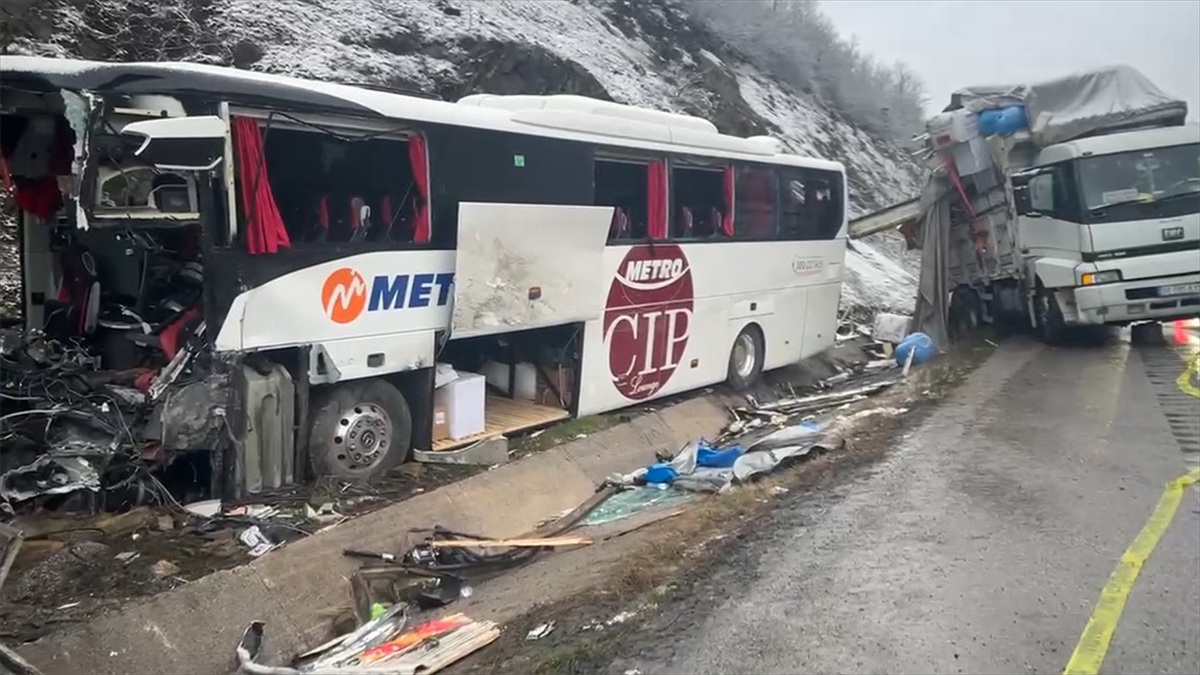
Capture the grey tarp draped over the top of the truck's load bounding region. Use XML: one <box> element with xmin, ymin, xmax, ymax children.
<box><xmin>949</xmin><ymin>66</ymin><xmax>1188</xmax><ymax>147</ymax></box>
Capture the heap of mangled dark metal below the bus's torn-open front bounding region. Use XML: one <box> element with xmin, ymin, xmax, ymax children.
<box><xmin>0</xmin><ymin>324</ymin><xmax>225</xmax><ymax>510</ymax></box>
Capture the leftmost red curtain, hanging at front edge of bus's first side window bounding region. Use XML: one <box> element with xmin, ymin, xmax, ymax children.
<box><xmin>233</xmin><ymin>118</ymin><xmax>292</xmax><ymax>255</ymax></box>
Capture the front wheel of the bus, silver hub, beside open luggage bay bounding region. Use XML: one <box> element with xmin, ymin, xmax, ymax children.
<box><xmin>308</xmin><ymin>380</ymin><xmax>413</xmax><ymax>483</ymax></box>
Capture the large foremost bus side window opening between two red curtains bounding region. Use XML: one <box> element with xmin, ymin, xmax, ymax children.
<box><xmin>259</xmin><ymin>127</ymin><xmax>427</xmax><ymax>245</ymax></box>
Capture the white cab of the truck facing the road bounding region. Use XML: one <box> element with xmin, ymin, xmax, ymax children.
<box><xmin>1013</xmin><ymin>124</ymin><xmax>1200</xmax><ymax>325</ymax></box>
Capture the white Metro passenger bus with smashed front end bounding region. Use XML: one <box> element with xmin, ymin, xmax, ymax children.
<box><xmin>0</xmin><ymin>56</ymin><xmax>846</xmax><ymax>491</ymax></box>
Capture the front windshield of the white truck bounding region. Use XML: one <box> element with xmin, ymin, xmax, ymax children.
<box><xmin>1079</xmin><ymin>143</ymin><xmax>1200</xmax><ymax>222</ymax></box>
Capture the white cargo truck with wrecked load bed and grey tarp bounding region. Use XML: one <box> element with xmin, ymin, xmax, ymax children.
<box><xmin>851</xmin><ymin>66</ymin><xmax>1200</xmax><ymax>342</ymax></box>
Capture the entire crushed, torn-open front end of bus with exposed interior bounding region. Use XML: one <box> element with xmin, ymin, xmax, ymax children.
<box><xmin>0</xmin><ymin>80</ymin><xmax>241</xmax><ymax>514</ymax></box>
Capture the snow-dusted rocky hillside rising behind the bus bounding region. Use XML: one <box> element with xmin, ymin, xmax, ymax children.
<box><xmin>2</xmin><ymin>0</ymin><xmax>918</xmax><ymax>309</ymax></box>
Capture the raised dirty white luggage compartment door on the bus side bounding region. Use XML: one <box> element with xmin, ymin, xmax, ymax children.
<box><xmin>450</xmin><ymin>198</ymin><xmax>613</xmax><ymax>338</ymax></box>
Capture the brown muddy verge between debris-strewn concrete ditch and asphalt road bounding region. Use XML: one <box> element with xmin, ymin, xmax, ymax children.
<box><xmin>448</xmin><ymin>342</ymin><xmax>992</xmax><ymax>675</ymax></box>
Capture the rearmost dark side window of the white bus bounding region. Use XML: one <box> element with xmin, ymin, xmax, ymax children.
<box><xmin>779</xmin><ymin>168</ymin><xmax>841</xmax><ymax>241</ymax></box>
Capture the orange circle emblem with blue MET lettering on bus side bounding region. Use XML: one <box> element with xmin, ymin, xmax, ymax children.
<box><xmin>320</xmin><ymin>267</ymin><xmax>454</xmax><ymax>324</ymax></box>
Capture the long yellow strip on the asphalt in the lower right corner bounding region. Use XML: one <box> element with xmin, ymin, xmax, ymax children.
<box><xmin>1063</xmin><ymin>468</ymin><xmax>1200</xmax><ymax>675</ymax></box>
